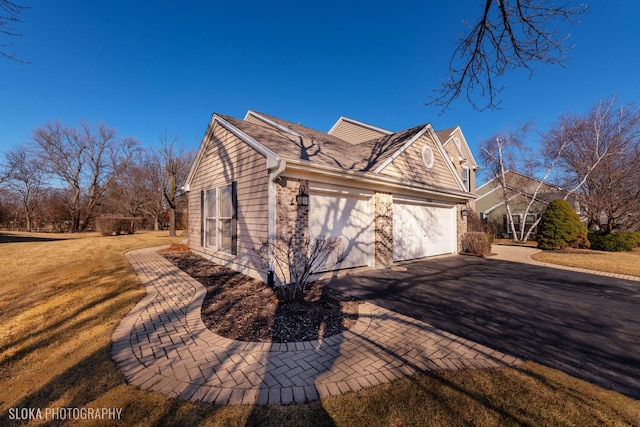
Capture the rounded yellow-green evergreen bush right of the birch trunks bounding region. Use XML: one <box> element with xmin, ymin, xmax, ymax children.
<box><xmin>538</xmin><ymin>199</ymin><xmax>589</xmax><ymax>250</ymax></box>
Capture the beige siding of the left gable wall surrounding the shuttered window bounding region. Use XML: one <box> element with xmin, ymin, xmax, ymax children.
<box><xmin>189</xmin><ymin>125</ymin><xmax>269</xmax><ymax>268</ymax></box>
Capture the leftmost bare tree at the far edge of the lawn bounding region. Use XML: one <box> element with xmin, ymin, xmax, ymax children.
<box><xmin>6</xmin><ymin>146</ymin><xmax>45</xmax><ymax>232</ymax></box>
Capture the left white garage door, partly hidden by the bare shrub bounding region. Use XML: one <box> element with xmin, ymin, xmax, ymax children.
<box><xmin>309</xmin><ymin>193</ymin><xmax>374</xmax><ymax>269</ymax></box>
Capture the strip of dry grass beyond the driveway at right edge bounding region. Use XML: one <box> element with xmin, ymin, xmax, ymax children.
<box><xmin>533</xmin><ymin>248</ymin><xmax>640</xmax><ymax>277</ymax></box>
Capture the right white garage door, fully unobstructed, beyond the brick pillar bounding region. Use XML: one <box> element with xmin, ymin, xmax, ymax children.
<box><xmin>393</xmin><ymin>202</ymin><xmax>457</xmax><ymax>261</ymax></box>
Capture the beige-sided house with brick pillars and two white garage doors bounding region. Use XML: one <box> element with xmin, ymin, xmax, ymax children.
<box><xmin>185</xmin><ymin>111</ymin><xmax>477</xmax><ymax>279</ymax></box>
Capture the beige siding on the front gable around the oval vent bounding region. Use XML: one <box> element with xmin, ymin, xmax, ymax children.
<box><xmin>381</xmin><ymin>134</ymin><xmax>460</xmax><ymax>191</ymax></box>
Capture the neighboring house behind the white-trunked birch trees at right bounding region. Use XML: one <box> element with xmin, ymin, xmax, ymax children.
<box><xmin>476</xmin><ymin>170</ymin><xmax>580</xmax><ymax>239</ymax></box>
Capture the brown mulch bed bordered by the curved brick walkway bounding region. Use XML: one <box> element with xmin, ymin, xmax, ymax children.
<box><xmin>161</xmin><ymin>247</ymin><xmax>359</xmax><ymax>342</ymax></box>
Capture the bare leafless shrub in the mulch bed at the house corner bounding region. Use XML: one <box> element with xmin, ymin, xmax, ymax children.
<box><xmin>254</xmin><ymin>235</ymin><xmax>345</xmax><ymax>301</ymax></box>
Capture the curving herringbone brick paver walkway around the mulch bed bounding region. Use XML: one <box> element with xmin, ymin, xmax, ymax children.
<box><xmin>111</xmin><ymin>248</ymin><xmax>519</xmax><ymax>405</ymax></box>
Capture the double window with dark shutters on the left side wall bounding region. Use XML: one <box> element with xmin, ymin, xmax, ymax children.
<box><xmin>203</xmin><ymin>183</ymin><xmax>237</xmax><ymax>254</ymax></box>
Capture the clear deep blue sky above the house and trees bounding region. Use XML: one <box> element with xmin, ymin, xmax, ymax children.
<box><xmin>0</xmin><ymin>0</ymin><xmax>640</xmax><ymax>182</ymax></box>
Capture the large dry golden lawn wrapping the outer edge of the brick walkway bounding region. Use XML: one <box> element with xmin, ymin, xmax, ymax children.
<box><xmin>0</xmin><ymin>233</ymin><xmax>640</xmax><ymax>427</ymax></box>
